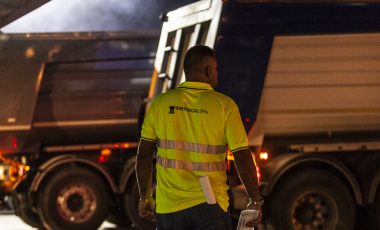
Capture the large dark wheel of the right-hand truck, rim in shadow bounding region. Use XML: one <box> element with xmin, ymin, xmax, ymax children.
<box><xmin>264</xmin><ymin>170</ymin><xmax>356</xmax><ymax>230</ymax></box>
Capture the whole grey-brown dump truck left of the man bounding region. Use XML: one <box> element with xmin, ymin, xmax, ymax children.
<box><xmin>0</xmin><ymin>31</ymin><xmax>158</xmax><ymax>229</ymax></box>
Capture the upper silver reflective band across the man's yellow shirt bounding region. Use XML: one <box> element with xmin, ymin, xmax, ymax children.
<box><xmin>158</xmin><ymin>140</ymin><xmax>227</xmax><ymax>154</ymax></box>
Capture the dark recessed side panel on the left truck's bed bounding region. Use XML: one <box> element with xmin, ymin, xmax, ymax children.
<box><xmin>33</xmin><ymin>58</ymin><xmax>153</xmax><ymax>146</ymax></box>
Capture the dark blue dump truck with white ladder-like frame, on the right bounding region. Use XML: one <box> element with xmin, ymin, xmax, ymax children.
<box><xmin>148</xmin><ymin>0</ymin><xmax>380</xmax><ymax>230</ymax></box>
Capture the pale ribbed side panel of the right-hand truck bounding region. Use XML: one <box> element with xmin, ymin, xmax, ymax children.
<box><xmin>258</xmin><ymin>33</ymin><xmax>380</xmax><ymax>135</ymax></box>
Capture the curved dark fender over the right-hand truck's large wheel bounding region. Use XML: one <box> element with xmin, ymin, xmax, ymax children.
<box><xmin>262</xmin><ymin>154</ymin><xmax>364</xmax><ymax>204</ymax></box>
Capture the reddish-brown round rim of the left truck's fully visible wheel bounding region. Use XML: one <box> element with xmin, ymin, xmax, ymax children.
<box><xmin>57</xmin><ymin>184</ymin><xmax>97</xmax><ymax>224</ymax></box>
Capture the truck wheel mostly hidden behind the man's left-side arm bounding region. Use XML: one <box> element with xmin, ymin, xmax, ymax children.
<box><xmin>124</xmin><ymin>176</ymin><xmax>156</xmax><ymax>230</ymax></box>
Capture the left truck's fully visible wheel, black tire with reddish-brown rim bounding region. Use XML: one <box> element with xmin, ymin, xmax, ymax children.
<box><xmin>38</xmin><ymin>167</ymin><xmax>109</xmax><ymax>230</ymax></box>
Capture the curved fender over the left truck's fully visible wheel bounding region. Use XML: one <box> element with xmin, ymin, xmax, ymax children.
<box><xmin>30</xmin><ymin>155</ymin><xmax>118</xmax><ymax>193</ymax></box>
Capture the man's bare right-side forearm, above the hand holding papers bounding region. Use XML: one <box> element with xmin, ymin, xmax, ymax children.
<box><xmin>233</xmin><ymin>149</ymin><xmax>261</xmax><ymax>210</ymax></box>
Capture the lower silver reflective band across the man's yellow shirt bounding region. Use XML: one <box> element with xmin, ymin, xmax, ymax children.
<box><xmin>157</xmin><ymin>156</ymin><xmax>227</xmax><ymax>172</ymax></box>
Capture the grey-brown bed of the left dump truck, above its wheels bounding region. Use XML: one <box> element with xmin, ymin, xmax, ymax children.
<box><xmin>0</xmin><ymin>31</ymin><xmax>158</xmax><ymax>153</ymax></box>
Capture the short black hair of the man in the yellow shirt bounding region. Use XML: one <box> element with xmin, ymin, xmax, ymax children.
<box><xmin>183</xmin><ymin>45</ymin><xmax>215</xmax><ymax>73</ymax></box>
